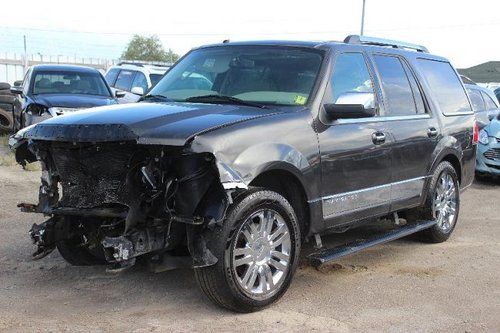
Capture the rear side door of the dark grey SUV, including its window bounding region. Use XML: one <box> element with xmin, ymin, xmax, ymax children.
<box><xmin>371</xmin><ymin>53</ymin><xmax>439</xmax><ymax>211</ymax></box>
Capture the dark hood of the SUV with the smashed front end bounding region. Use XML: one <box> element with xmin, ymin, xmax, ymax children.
<box><xmin>22</xmin><ymin>102</ymin><xmax>282</xmax><ymax>146</ymax></box>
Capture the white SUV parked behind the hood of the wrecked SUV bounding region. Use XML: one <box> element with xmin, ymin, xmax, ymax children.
<box><xmin>104</xmin><ymin>62</ymin><xmax>170</xmax><ymax>103</ymax></box>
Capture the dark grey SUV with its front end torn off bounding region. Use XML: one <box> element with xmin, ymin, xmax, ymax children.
<box><xmin>11</xmin><ymin>36</ymin><xmax>478</xmax><ymax>312</ymax></box>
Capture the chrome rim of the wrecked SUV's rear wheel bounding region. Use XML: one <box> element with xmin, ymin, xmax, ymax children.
<box><xmin>432</xmin><ymin>172</ymin><xmax>457</xmax><ymax>232</ymax></box>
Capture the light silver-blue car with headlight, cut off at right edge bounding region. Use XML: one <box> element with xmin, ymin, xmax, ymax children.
<box><xmin>476</xmin><ymin>114</ymin><xmax>500</xmax><ymax>177</ymax></box>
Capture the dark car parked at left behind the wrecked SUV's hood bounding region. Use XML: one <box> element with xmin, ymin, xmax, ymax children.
<box><xmin>11</xmin><ymin>65</ymin><xmax>122</xmax><ymax>130</ymax></box>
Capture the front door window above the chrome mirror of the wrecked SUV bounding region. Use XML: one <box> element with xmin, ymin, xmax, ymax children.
<box><xmin>330</xmin><ymin>52</ymin><xmax>375</xmax><ymax>108</ymax></box>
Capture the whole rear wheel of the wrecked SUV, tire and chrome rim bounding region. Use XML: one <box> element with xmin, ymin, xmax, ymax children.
<box><xmin>408</xmin><ymin>161</ymin><xmax>460</xmax><ymax>243</ymax></box>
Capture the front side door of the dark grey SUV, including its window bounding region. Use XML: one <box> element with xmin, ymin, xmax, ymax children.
<box><xmin>316</xmin><ymin>51</ymin><xmax>392</xmax><ymax>227</ymax></box>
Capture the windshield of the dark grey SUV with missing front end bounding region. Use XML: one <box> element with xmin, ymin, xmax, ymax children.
<box><xmin>150</xmin><ymin>46</ymin><xmax>323</xmax><ymax>105</ymax></box>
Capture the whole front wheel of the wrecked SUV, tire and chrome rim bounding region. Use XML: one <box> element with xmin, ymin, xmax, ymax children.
<box><xmin>195</xmin><ymin>188</ymin><xmax>301</xmax><ymax>312</ymax></box>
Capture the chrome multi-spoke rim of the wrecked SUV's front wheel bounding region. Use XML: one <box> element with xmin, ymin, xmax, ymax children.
<box><xmin>232</xmin><ymin>209</ymin><xmax>291</xmax><ymax>299</ymax></box>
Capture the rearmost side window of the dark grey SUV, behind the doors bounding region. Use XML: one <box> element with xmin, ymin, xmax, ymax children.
<box><xmin>418</xmin><ymin>58</ymin><xmax>471</xmax><ymax>115</ymax></box>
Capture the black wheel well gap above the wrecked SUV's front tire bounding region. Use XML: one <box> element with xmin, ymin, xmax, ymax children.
<box><xmin>250</xmin><ymin>170</ymin><xmax>310</xmax><ymax>239</ymax></box>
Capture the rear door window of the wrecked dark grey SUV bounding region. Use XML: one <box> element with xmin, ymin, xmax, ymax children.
<box><xmin>374</xmin><ymin>55</ymin><xmax>422</xmax><ymax>116</ymax></box>
